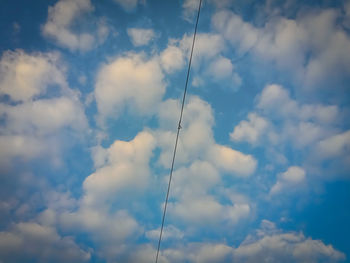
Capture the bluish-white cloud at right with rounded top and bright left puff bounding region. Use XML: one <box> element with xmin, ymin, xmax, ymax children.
<box><xmin>230</xmin><ymin>84</ymin><xmax>340</xmax><ymax>149</ymax></box>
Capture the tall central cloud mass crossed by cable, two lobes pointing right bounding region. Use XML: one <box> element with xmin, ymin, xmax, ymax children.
<box><xmin>155</xmin><ymin>97</ymin><xmax>257</xmax><ymax>226</ymax></box>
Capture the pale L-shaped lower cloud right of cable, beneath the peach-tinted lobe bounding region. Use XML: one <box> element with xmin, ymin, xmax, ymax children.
<box><xmin>169</xmin><ymin>161</ymin><xmax>251</xmax><ymax>226</ymax></box>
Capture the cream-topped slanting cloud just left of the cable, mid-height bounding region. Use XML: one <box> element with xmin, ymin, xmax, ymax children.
<box><xmin>83</xmin><ymin>132</ymin><xmax>156</xmax><ymax>205</ymax></box>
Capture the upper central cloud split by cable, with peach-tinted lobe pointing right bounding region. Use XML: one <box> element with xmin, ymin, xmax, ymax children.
<box><xmin>156</xmin><ymin>97</ymin><xmax>257</xmax><ymax>176</ymax></box>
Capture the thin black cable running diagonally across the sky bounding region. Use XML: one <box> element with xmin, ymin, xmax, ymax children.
<box><xmin>156</xmin><ymin>0</ymin><xmax>202</xmax><ymax>263</ymax></box>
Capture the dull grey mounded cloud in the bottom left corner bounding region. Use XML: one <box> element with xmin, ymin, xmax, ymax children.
<box><xmin>0</xmin><ymin>222</ymin><xmax>91</xmax><ymax>262</ymax></box>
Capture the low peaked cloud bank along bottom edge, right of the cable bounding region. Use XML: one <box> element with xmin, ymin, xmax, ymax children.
<box><xmin>152</xmin><ymin>220</ymin><xmax>345</xmax><ymax>263</ymax></box>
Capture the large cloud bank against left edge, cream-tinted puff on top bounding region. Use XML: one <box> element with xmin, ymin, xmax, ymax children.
<box><xmin>0</xmin><ymin>50</ymin><xmax>88</xmax><ymax>163</ymax></box>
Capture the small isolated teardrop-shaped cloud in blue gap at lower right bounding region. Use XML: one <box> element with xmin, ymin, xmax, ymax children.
<box><xmin>270</xmin><ymin>166</ymin><xmax>306</xmax><ymax>195</ymax></box>
